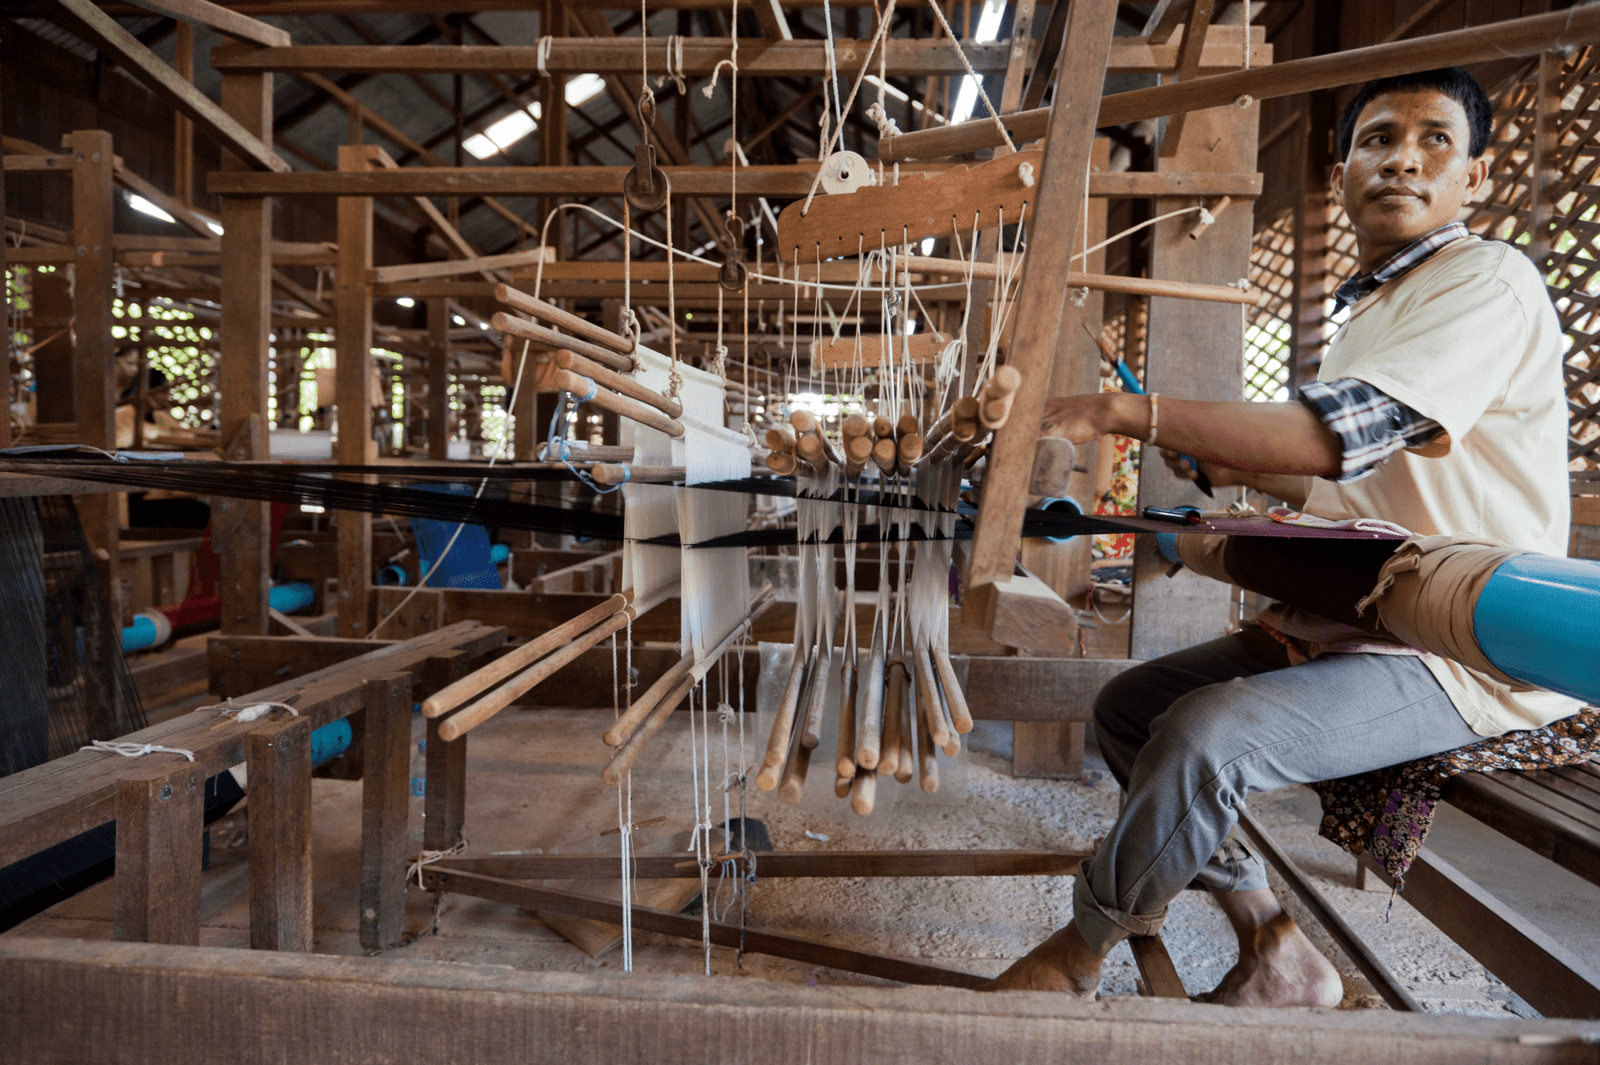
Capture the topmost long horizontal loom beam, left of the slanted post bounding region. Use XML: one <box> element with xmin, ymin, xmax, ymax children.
<box><xmin>212</xmin><ymin>39</ymin><xmax>1010</xmax><ymax>78</ymax></box>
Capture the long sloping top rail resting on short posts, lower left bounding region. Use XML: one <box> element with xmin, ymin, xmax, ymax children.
<box><xmin>0</xmin><ymin>622</ymin><xmax>506</xmax><ymax>867</ymax></box>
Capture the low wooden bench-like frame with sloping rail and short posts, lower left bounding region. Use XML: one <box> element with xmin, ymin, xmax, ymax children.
<box><xmin>0</xmin><ymin>622</ymin><xmax>506</xmax><ymax>950</ymax></box>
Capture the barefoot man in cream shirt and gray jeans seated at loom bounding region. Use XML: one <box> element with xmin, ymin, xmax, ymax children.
<box><xmin>994</xmin><ymin>67</ymin><xmax>1579</xmax><ymax>1006</ymax></box>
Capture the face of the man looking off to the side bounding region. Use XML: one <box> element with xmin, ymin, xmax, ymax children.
<box><xmin>1333</xmin><ymin>90</ymin><xmax>1488</xmax><ymax>270</ymax></box>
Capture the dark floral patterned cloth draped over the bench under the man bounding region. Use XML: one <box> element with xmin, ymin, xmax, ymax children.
<box><xmin>1310</xmin><ymin>707</ymin><xmax>1600</xmax><ymax>891</ymax></box>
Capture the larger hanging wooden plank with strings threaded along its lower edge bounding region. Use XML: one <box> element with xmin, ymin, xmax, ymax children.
<box><xmin>778</xmin><ymin>152</ymin><xmax>1043</xmax><ymax>262</ymax></box>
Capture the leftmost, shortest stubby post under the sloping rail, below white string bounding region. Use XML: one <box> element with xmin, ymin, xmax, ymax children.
<box><xmin>112</xmin><ymin>761</ymin><xmax>205</xmax><ymax>947</ymax></box>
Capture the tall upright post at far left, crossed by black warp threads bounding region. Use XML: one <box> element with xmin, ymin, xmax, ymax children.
<box><xmin>69</xmin><ymin>130</ymin><xmax>125</xmax><ymax>625</ymax></box>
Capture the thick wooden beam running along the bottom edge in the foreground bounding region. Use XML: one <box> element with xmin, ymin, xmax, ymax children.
<box><xmin>9</xmin><ymin>940</ymin><xmax>1595</xmax><ymax>1065</ymax></box>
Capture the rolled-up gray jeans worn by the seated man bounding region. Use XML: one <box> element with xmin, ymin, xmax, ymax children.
<box><xmin>1074</xmin><ymin>628</ymin><xmax>1482</xmax><ymax>953</ymax></box>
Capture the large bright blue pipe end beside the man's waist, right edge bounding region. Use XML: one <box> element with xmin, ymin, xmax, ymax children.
<box><xmin>1472</xmin><ymin>555</ymin><xmax>1600</xmax><ymax>704</ymax></box>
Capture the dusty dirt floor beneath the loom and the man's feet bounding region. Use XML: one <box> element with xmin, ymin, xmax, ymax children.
<box><xmin>11</xmin><ymin>651</ymin><xmax>1533</xmax><ymax>1015</ymax></box>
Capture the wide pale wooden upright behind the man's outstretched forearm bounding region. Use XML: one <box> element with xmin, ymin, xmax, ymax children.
<box><xmin>1130</xmin><ymin>62</ymin><xmax>1261</xmax><ymax>659</ymax></box>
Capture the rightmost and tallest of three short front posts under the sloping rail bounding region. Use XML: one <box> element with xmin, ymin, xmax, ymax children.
<box><xmin>360</xmin><ymin>673</ymin><xmax>411</xmax><ymax>950</ymax></box>
